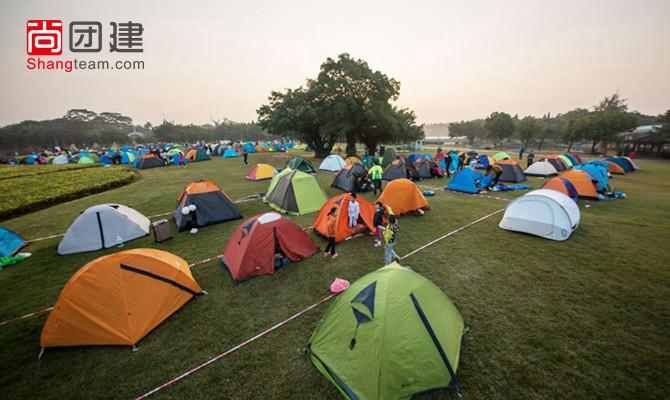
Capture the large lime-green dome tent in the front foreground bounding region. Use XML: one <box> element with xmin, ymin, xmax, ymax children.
<box><xmin>307</xmin><ymin>263</ymin><xmax>467</xmax><ymax>400</ymax></box>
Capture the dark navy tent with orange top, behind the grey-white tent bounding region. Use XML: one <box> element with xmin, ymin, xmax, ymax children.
<box><xmin>172</xmin><ymin>180</ymin><xmax>242</xmax><ymax>232</ymax></box>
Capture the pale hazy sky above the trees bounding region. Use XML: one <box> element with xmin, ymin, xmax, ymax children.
<box><xmin>0</xmin><ymin>0</ymin><xmax>670</xmax><ymax>125</ymax></box>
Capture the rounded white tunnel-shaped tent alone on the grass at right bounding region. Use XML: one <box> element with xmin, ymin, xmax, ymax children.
<box><xmin>499</xmin><ymin>189</ymin><xmax>579</xmax><ymax>241</ymax></box>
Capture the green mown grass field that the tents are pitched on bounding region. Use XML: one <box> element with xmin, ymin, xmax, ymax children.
<box><xmin>0</xmin><ymin>153</ymin><xmax>670</xmax><ymax>399</ymax></box>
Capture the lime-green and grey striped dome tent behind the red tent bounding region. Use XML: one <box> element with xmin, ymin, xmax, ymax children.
<box><xmin>263</xmin><ymin>168</ymin><xmax>328</xmax><ymax>215</ymax></box>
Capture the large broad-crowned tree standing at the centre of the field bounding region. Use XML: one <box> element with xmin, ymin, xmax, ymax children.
<box><xmin>257</xmin><ymin>53</ymin><xmax>423</xmax><ymax>157</ymax></box>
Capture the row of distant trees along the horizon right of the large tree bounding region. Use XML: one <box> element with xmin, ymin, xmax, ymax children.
<box><xmin>449</xmin><ymin>92</ymin><xmax>670</xmax><ymax>153</ymax></box>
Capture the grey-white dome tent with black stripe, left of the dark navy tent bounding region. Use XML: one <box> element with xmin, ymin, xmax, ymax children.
<box><xmin>58</xmin><ymin>204</ymin><xmax>151</xmax><ymax>255</ymax></box>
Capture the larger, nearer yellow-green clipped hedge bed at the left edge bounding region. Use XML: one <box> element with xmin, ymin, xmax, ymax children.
<box><xmin>0</xmin><ymin>167</ymin><xmax>137</xmax><ymax>220</ymax></box>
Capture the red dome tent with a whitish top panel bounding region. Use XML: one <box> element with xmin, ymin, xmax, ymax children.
<box><xmin>221</xmin><ymin>212</ymin><xmax>319</xmax><ymax>284</ymax></box>
